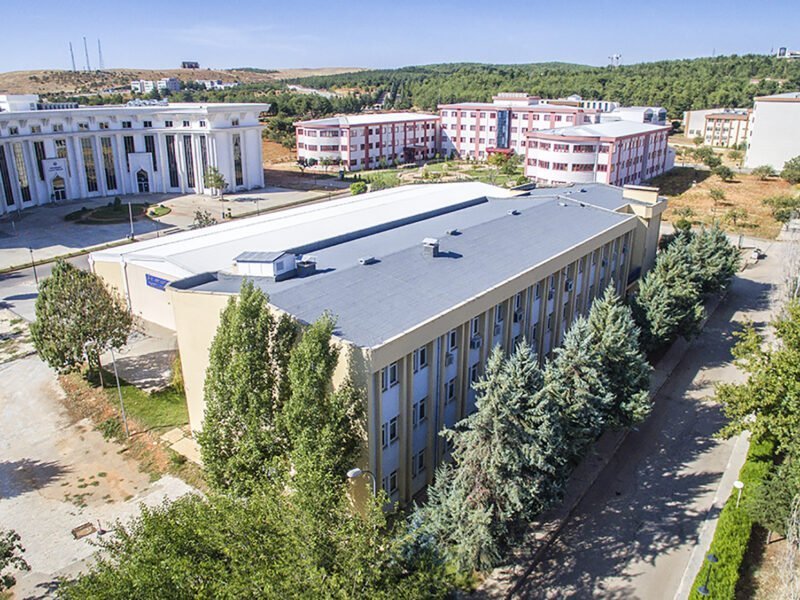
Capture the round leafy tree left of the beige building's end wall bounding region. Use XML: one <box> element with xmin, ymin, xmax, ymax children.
<box><xmin>31</xmin><ymin>260</ymin><xmax>133</xmax><ymax>372</ymax></box>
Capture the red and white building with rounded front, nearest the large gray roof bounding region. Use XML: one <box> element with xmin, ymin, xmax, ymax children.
<box><xmin>525</xmin><ymin>121</ymin><xmax>675</xmax><ymax>186</ymax></box>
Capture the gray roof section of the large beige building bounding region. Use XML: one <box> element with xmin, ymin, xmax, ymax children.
<box><xmin>181</xmin><ymin>184</ymin><xmax>635</xmax><ymax>347</ymax></box>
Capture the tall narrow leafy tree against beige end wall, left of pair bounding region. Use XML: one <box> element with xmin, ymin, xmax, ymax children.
<box><xmin>197</xmin><ymin>280</ymin><xmax>295</xmax><ymax>495</ymax></box>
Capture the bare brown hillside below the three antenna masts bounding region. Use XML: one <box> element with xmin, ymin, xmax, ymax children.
<box><xmin>0</xmin><ymin>67</ymin><xmax>363</xmax><ymax>96</ymax></box>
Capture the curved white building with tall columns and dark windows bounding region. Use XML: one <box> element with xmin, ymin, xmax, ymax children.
<box><xmin>0</xmin><ymin>101</ymin><xmax>269</xmax><ymax>215</ymax></box>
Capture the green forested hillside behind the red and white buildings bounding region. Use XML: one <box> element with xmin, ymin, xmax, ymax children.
<box><xmin>292</xmin><ymin>54</ymin><xmax>800</xmax><ymax>119</ymax></box>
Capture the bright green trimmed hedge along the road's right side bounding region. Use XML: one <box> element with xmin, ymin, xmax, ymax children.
<box><xmin>689</xmin><ymin>440</ymin><xmax>775</xmax><ymax>600</ymax></box>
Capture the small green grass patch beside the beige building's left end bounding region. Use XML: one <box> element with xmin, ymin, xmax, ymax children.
<box><xmin>104</xmin><ymin>378</ymin><xmax>189</xmax><ymax>431</ymax></box>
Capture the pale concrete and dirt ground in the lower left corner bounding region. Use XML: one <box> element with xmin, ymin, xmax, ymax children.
<box><xmin>0</xmin><ymin>356</ymin><xmax>192</xmax><ymax>598</ymax></box>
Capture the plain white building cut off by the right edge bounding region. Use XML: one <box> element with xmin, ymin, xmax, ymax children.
<box><xmin>744</xmin><ymin>92</ymin><xmax>800</xmax><ymax>171</ymax></box>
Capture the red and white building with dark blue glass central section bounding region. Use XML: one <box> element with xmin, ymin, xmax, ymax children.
<box><xmin>439</xmin><ymin>93</ymin><xmax>600</xmax><ymax>160</ymax></box>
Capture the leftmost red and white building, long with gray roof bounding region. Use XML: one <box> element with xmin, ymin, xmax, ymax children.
<box><xmin>294</xmin><ymin>113</ymin><xmax>439</xmax><ymax>171</ymax></box>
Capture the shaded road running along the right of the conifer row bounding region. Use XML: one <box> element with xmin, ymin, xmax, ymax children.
<box><xmin>518</xmin><ymin>242</ymin><xmax>787</xmax><ymax>600</ymax></box>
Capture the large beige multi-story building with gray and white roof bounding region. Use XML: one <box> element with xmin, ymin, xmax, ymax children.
<box><xmin>92</xmin><ymin>183</ymin><xmax>666</xmax><ymax>502</ymax></box>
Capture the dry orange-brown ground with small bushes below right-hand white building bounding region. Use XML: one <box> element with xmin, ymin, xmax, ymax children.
<box><xmin>651</xmin><ymin>167</ymin><xmax>797</xmax><ymax>239</ymax></box>
